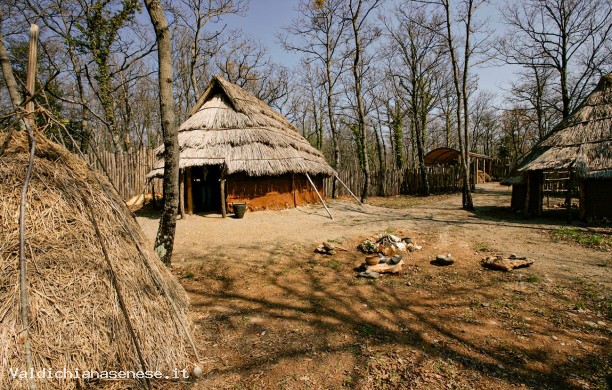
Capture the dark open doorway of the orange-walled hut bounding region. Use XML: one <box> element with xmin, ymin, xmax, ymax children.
<box><xmin>191</xmin><ymin>166</ymin><xmax>221</xmax><ymax>213</ymax></box>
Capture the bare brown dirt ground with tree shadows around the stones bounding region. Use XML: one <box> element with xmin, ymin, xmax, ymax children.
<box><xmin>138</xmin><ymin>184</ymin><xmax>612</xmax><ymax>389</ymax></box>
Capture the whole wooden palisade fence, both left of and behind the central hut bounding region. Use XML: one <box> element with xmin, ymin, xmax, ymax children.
<box><xmin>80</xmin><ymin>148</ymin><xmax>509</xmax><ymax>201</ymax></box>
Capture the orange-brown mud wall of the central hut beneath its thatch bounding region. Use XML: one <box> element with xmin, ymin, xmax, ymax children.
<box><xmin>226</xmin><ymin>175</ymin><xmax>323</xmax><ymax>210</ymax></box>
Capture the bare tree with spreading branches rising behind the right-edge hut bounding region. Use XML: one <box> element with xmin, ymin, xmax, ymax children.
<box><xmin>498</xmin><ymin>0</ymin><xmax>612</xmax><ymax>118</ymax></box>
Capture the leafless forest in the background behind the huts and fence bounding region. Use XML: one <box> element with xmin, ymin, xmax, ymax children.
<box><xmin>0</xmin><ymin>0</ymin><xmax>612</xmax><ymax>195</ymax></box>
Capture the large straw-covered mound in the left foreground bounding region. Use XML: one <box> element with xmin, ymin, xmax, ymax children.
<box><xmin>0</xmin><ymin>132</ymin><xmax>193</xmax><ymax>389</ymax></box>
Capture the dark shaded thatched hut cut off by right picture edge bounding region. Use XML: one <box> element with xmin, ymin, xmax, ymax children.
<box><xmin>505</xmin><ymin>74</ymin><xmax>612</xmax><ymax>219</ymax></box>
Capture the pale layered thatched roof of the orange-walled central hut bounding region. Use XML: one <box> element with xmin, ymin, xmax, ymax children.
<box><xmin>147</xmin><ymin>76</ymin><xmax>335</xmax><ymax>177</ymax></box>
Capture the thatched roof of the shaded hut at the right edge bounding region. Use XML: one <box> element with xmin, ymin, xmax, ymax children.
<box><xmin>517</xmin><ymin>74</ymin><xmax>612</xmax><ymax>178</ymax></box>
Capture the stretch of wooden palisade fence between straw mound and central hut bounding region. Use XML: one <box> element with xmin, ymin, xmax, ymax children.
<box><xmin>85</xmin><ymin>148</ymin><xmax>162</xmax><ymax>201</ymax></box>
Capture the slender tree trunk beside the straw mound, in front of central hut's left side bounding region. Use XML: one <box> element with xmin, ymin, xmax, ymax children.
<box><xmin>144</xmin><ymin>0</ymin><xmax>179</xmax><ymax>265</ymax></box>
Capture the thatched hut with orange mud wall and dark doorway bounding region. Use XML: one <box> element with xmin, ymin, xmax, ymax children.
<box><xmin>148</xmin><ymin>76</ymin><xmax>335</xmax><ymax>213</ymax></box>
